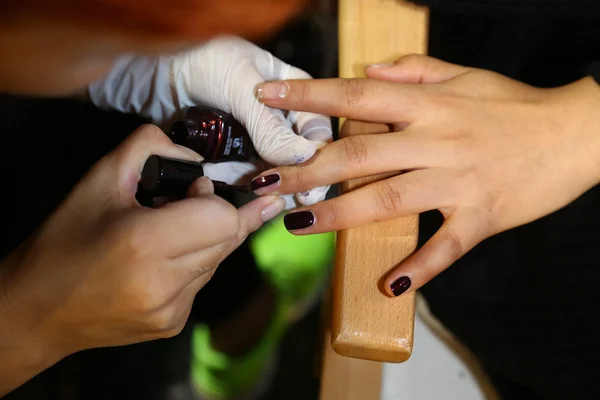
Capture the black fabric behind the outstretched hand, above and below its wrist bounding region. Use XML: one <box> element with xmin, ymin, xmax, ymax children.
<box><xmin>420</xmin><ymin>10</ymin><xmax>600</xmax><ymax>400</ymax></box>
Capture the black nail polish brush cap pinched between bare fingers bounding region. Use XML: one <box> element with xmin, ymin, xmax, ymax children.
<box><xmin>140</xmin><ymin>155</ymin><xmax>204</xmax><ymax>198</ymax></box>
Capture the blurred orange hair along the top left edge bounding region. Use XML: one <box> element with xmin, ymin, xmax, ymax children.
<box><xmin>0</xmin><ymin>0</ymin><xmax>306</xmax><ymax>40</ymax></box>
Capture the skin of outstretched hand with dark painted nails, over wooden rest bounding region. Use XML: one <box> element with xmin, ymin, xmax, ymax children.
<box><xmin>257</xmin><ymin>56</ymin><xmax>600</xmax><ymax>295</ymax></box>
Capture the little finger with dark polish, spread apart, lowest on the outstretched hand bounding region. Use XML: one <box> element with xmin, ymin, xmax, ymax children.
<box><xmin>385</xmin><ymin>210</ymin><xmax>486</xmax><ymax>296</ymax></box>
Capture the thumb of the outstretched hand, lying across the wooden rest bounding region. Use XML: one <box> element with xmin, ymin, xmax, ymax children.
<box><xmin>365</xmin><ymin>54</ymin><xmax>471</xmax><ymax>83</ymax></box>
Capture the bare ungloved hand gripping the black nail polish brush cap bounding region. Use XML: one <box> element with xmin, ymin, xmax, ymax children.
<box><xmin>0</xmin><ymin>126</ymin><xmax>284</xmax><ymax>356</ymax></box>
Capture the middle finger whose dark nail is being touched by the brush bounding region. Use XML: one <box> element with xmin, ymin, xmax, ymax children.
<box><xmin>252</xmin><ymin>131</ymin><xmax>437</xmax><ymax>196</ymax></box>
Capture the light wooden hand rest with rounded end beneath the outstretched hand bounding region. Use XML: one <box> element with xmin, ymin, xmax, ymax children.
<box><xmin>331</xmin><ymin>0</ymin><xmax>428</xmax><ymax>362</ymax></box>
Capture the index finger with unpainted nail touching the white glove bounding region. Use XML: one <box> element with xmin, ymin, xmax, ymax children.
<box><xmin>257</xmin><ymin>78</ymin><xmax>427</xmax><ymax>123</ymax></box>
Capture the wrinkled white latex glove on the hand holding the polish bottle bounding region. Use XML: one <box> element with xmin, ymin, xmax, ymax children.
<box><xmin>88</xmin><ymin>36</ymin><xmax>332</xmax><ymax>206</ymax></box>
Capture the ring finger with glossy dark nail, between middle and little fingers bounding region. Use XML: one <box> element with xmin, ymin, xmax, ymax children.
<box><xmin>284</xmin><ymin>169</ymin><xmax>458</xmax><ymax>235</ymax></box>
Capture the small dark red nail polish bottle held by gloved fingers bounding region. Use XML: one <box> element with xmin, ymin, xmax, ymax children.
<box><xmin>169</xmin><ymin>107</ymin><xmax>255</xmax><ymax>163</ymax></box>
